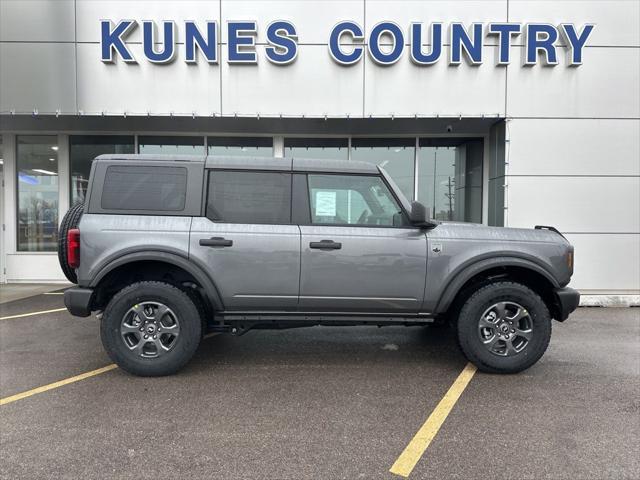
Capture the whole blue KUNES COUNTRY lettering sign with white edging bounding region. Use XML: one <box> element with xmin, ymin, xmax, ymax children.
<box><xmin>99</xmin><ymin>19</ymin><xmax>595</xmax><ymax>66</ymax></box>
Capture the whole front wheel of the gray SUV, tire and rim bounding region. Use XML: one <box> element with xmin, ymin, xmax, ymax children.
<box><xmin>456</xmin><ymin>281</ymin><xmax>551</xmax><ymax>373</ymax></box>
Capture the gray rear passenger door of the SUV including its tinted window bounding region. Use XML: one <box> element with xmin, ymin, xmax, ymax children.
<box><xmin>190</xmin><ymin>169</ymin><xmax>300</xmax><ymax>310</ymax></box>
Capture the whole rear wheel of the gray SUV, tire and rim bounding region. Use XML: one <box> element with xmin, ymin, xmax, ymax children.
<box><xmin>100</xmin><ymin>282</ymin><xmax>202</xmax><ymax>376</ymax></box>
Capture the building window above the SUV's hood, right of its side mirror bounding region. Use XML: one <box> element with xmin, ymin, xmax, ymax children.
<box><xmin>417</xmin><ymin>138</ymin><xmax>483</xmax><ymax>223</ymax></box>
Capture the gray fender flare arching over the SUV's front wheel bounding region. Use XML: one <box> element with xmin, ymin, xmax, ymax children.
<box><xmin>435</xmin><ymin>255</ymin><xmax>560</xmax><ymax>313</ymax></box>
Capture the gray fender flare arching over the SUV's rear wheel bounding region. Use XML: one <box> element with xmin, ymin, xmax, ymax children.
<box><xmin>89</xmin><ymin>250</ymin><xmax>224</xmax><ymax>310</ymax></box>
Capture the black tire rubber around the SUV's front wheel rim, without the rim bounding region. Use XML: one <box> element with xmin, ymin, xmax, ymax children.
<box><xmin>456</xmin><ymin>281</ymin><xmax>551</xmax><ymax>373</ymax></box>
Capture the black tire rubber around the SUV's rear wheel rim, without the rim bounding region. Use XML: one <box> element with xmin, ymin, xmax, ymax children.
<box><xmin>100</xmin><ymin>281</ymin><xmax>202</xmax><ymax>377</ymax></box>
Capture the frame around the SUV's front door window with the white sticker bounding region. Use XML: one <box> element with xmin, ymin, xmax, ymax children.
<box><xmin>292</xmin><ymin>172</ymin><xmax>410</xmax><ymax>229</ymax></box>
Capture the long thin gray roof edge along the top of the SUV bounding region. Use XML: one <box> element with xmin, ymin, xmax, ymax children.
<box><xmin>96</xmin><ymin>154</ymin><xmax>378</xmax><ymax>174</ymax></box>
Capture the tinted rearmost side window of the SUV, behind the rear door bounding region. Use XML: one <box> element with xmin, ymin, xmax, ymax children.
<box><xmin>101</xmin><ymin>165</ymin><xmax>187</xmax><ymax>212</ymax></box>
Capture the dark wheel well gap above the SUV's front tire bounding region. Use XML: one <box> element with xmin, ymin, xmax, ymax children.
<box><xmin>446</xmin><ymin>266</ymin><xmax>560</xmax><ymax>319</ymax></box>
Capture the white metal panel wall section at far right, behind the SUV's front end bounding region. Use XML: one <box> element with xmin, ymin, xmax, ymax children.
<box><xmin>504</xmin><ymin>0</ymin><xmax>640</xmax><ymax>295</ymax></box>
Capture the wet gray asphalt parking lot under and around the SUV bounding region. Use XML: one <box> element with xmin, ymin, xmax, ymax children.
<box><xmin>0</xmin><ymin>288</ymin><xmax>640</xmax><ymax>479</ymax></box>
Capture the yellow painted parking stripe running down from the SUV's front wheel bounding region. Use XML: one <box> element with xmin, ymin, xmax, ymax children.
<box><xmin>389</xmin><ymin>363</ymin><xmax>477</xmax><ymax>477</ymax></box>
